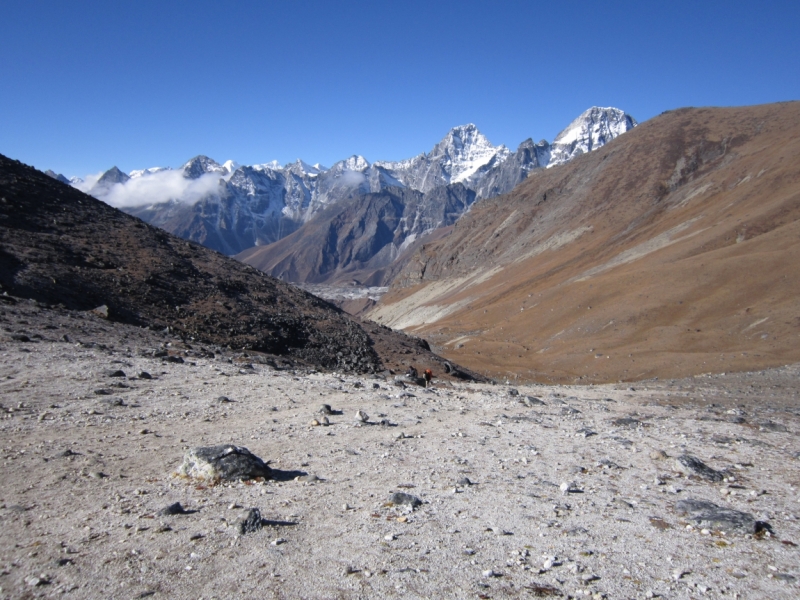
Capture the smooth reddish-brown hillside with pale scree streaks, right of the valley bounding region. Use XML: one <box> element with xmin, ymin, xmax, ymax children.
<box><xmin>370</xmin><ymin>102</ymin><xmax>800</xmax><ymax>382</ymax></box>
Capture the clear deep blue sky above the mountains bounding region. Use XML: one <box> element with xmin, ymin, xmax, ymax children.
<box><xmin>0</xmin><ymin>0</ymin><xmax>800</xmax><ymax>176</ymax></box>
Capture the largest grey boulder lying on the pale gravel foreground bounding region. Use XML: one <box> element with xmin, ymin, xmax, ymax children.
<box><xmin>178</xmin><ymin>444</ymin><xmax>272</xmax><ymax>481</ymax></box>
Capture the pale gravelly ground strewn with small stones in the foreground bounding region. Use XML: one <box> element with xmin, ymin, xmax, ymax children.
<box><xmin>0</xmin><ymin>297</ymin><xmax>800</xmax><ymax>598</ymax></box>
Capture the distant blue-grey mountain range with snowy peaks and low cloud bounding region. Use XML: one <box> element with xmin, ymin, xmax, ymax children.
<box><xmin>53</xmin><ymin>107</ymin><xmax>637</xmax><ymax>264</ymax></box>
